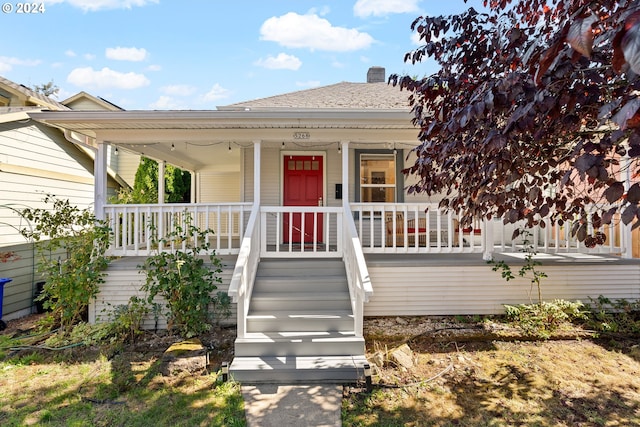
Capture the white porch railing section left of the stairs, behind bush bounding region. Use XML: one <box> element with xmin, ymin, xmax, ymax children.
<box><xmin>105</xmin><ymin>203</ymin><xmax>252</xmax><ymax>256</ymax></box>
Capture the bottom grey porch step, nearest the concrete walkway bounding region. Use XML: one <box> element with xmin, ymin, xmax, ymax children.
<box><xmin>229</xmin><ymin>356</ymin><xmax>367</xmax><ymax>384</ymax></box>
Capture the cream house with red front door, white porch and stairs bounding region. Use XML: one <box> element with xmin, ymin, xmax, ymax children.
<box><xmin>31</xmin><ymin>67</ymin><xmax>640</xmax><ymax>382</ymax></box>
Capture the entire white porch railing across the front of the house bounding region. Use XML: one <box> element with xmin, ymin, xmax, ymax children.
<box><xmin>105</xmin><ymin>203</ymin><xmax>631</xmax><ymax>258</ymax></box>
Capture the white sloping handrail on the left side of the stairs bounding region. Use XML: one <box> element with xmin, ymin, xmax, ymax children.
<box><xmin>227</xmin><ymin>204</ymin><xmax>260</xmax><ymax>338</ymax></box>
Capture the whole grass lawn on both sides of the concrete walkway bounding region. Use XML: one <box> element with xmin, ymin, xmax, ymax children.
<box><xmin>0</xmin><ymin>314</ymin><xmax>640</xmax><ymax>427</ymax></box>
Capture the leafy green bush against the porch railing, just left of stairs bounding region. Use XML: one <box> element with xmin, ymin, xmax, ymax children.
<box><xmin>141</xmin><ymin>212</ymin><xmax>224</xmax><ymax>337</ymax></box>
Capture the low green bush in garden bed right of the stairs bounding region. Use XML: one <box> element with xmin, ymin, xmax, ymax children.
<box><xmin>504</xmin><ymin>300</ymin><xmax>586</xmax><ymax>339</ymax></box>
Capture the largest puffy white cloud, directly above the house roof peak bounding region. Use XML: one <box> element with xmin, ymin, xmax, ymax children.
<box><xmin>260</xmin><ymin>12</ymin><xmax>375</xmax><ymax>52</ymax></box>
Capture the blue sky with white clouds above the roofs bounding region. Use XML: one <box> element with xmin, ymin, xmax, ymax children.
<box><xmin>0</xmin><ymin>0</ymin><xmax>481</xmax><ymax>110</ymax></box>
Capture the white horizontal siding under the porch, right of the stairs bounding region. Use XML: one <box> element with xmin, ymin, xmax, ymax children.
<box><xmin>365</xmin><ymin>262</ymin><xmax>640</xmax><ymax>316</ymax></box>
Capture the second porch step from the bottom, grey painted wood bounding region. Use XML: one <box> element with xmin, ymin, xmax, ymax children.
<box><xmin>234</xmin><ymin>331</ymin><xmax>365</xmax><ymax>357</ymax></box>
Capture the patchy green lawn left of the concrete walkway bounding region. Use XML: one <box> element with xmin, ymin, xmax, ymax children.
<box><xmin>0</xmin><ymin>350</ymin><xmax>245</xmax><ymax>427</ymax></box>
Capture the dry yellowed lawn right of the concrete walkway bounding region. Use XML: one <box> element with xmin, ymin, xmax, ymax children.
<box><xmin>343</xmin><ymin>342</ymin><xmax>640</xmax><ymax>427</ymax></box>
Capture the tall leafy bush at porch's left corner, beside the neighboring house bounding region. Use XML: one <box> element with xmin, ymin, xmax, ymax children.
<box><xmin>21</xmin><ymin>195</ymin><xmax>110</xmax><ymax>332</ymax></box>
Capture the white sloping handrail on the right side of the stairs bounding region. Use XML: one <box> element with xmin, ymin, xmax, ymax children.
<box><xmin>342</xmin><ymin>206</ymin><xmax>373</xmax><ymax>337</ymax></box>
